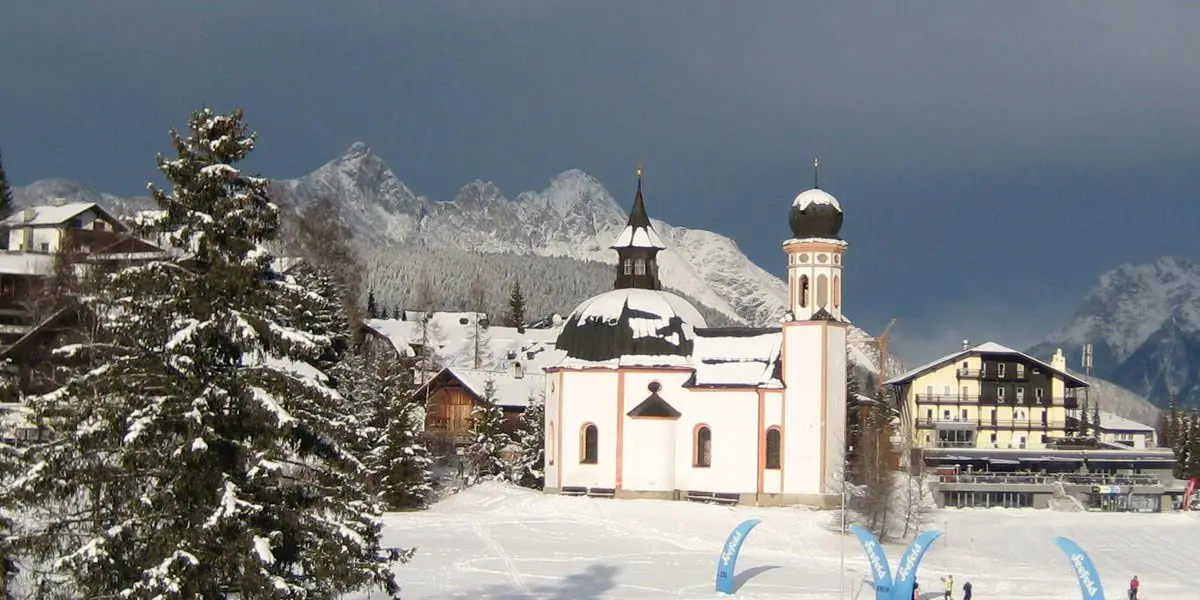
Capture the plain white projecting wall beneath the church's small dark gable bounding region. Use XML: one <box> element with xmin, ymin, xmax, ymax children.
<box><xmin>620</xmin><ymin>416</ymin><xmax>676</xmax><ymax>492</ymax></box>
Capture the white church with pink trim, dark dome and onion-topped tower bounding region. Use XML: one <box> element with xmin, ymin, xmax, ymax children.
<box><xmin>545</xmin><ymin>170</ymin><xmax>848</xmax><ymax>506</ymax></box>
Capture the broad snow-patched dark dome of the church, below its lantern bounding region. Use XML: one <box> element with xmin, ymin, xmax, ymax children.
<box><xmin>554</xmin><ymin>288</ymin><xmax>708</xmax><ymax>362</ymax></box>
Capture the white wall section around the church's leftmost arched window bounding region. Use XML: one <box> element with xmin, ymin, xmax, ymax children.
<box><xmin>558</xmin><ymin>370</ymin><xmax>617</xmax><ymax>488</ymax></box>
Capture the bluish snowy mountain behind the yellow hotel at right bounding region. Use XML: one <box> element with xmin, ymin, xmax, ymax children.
<box><xmin>1030</xmin><ymin>257</ymin><xmax>1200</xmax><ymax>407</ymax></box>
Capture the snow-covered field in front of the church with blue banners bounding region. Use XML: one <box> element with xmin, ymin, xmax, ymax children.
<box><xmin>374</xmin><ymin>484</ymin><xmax>1200</xmax><ymax>600</ymax></box>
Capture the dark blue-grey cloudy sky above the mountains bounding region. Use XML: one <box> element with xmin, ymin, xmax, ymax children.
<box><xmin>0</xmin><ymin>0</ymin><xmax>1200</xmax><ymax>360</ymax></box>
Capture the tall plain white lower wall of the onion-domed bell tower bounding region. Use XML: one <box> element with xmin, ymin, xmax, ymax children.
<box><xmin>782</xmin><ymin>322</ymin><xmax>828</xmax><ymax>494</ymax></box>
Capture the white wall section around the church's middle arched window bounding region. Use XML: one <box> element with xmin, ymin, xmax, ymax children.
<box><xmin>676</xmin><ymin>389</ymin><xmax>758</xmax><ymax>493</ymax></box>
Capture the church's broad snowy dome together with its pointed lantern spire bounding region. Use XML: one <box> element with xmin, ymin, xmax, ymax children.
<box><xmin>554</xmin><ymin>167</ymin><xmax>707</xmax><ymax>366</ymax></box>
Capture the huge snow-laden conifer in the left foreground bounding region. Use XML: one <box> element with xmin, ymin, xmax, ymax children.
<box><xmin>13</xmin><ymin>109</ymin><xmax>409</xmax><ymax>600</ymax></box>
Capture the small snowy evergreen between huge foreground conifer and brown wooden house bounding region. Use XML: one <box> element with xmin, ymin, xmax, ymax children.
<box><xmin>338</xmin><ymin>354</ymin><xmax>433</xmax><ymax>510</ymax></box>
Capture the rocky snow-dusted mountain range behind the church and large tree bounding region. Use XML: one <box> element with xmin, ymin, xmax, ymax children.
<box><xmin>17</xmin><ymin>143</ymin><xmax>902</xmax><ymax>373</ymax></box>
